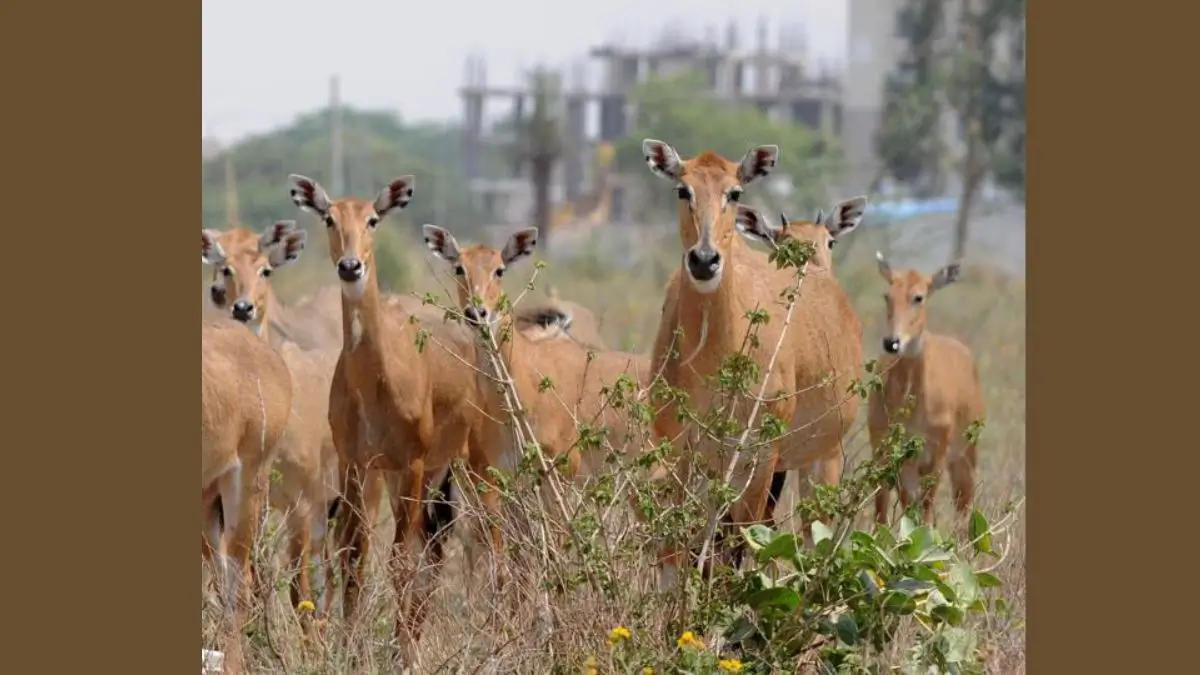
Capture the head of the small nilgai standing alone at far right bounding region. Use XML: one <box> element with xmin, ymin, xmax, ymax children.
<box><xmin>875</xmin><ymin>251</ymin><xmax>961</xmax><ymax>356</ymax></box>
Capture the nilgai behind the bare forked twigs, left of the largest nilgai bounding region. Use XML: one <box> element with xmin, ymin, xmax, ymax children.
<box><xmin>424</xmin><ymin>225</ymin><xmax>649</xmax><ymax>478</ymax></box>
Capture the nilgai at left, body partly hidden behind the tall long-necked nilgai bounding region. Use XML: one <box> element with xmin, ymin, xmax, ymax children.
<box><xmin>204</xmin><ymin>221</ymin><xmax>338</xmax><ymax>628</ymax></box>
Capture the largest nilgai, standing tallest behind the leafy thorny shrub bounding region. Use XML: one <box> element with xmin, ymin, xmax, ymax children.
<box><xmin>642</xmin><ymin>139</ymin><xmax>865</xmax><ymax>586</ymax></box>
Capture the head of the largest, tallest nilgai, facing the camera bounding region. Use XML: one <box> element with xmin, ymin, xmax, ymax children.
<box><xmin>642</xmin><ymin>138</ymin><xmax>779</xmax><ymax>293</ymax></box>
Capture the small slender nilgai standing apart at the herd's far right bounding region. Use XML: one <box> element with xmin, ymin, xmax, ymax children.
<box><xmin>866</xmin><ymin>252</ymin><xmax>984</xmax><ymax>522</ymax></box>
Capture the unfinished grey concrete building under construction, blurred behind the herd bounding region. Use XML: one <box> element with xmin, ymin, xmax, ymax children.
<box><xmin>460</xmin><ymin>7</ymin><xmax>898</xmax><ymax>227</ymax></box>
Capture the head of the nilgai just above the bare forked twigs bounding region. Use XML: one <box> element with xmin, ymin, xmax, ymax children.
<box><xmin>422</xmin><ymin>225</ymin><xmax>538</xmax><ymax>325</ymax></box>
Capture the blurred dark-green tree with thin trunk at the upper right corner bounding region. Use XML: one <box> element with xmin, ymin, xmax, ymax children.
<box><xmin>876</xmin><ymin>0</ymin><xmax>1025</xmax><ymax>258</ymax></box>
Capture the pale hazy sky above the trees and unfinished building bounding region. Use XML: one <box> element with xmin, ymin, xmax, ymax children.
<box><xmin>202</xmin><ymin>0</ymin><xmax>846</xmax><ymax>142</ymax></box>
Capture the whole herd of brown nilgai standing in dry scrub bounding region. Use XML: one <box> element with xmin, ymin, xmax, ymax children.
<box><xmin>200</xmin><ymin>139</ymin><xmax>983</xmax><ymax>662</ymax></box>
